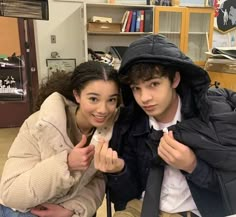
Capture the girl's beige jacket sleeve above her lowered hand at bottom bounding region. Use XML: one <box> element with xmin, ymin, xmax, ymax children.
<box><xmin>60</xmin><ymin>173</ymin><xmax>105</xmax><ymax>217</ymax></box>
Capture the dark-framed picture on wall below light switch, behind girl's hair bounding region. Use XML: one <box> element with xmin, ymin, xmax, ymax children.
<box><xmin>46</xmin><ymin>58</ymin><xmax>76</xmax><ymax>76</ymax></box>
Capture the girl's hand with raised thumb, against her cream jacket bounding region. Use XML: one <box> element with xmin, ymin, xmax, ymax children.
<box><xmin>68</xmin><ymin>135</ymin><xmax>94</xmax><ymax>171</ymax></box>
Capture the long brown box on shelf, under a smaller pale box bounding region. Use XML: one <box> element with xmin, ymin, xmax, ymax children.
<box><xmin>87</xmin><ymin>22</ymin><xmax>121</xmax><ymax>32</ymax></box>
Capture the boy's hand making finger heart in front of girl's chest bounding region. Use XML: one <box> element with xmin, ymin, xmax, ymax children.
<box><xmin>94</xmin><ymin>139</ymin><xmax>125</xmax><ymax>173</ymax></box>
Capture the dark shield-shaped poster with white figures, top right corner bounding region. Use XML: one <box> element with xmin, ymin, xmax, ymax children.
<box><xmin>214</xmin><ymin>0</ymin><xmax>236</xmax><ymax>33</ymax></box>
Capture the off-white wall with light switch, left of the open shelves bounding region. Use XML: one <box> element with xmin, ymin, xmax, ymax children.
<box><xmin>34</xmin><ymin>0</ymin><xmax>105</xmax><ymax>82</ymax></box>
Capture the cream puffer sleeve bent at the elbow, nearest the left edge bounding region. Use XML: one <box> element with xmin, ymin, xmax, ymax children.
<box><xmin>0</xmin><ymin>121</ymin><xmax>75</xmax><ymax>211</ymax></box>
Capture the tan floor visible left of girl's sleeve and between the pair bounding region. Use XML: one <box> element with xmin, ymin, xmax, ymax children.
<box><xmin>0</xmin><ymin>128</ymin><xmax>110</xmax><ymax>217</ymax></box>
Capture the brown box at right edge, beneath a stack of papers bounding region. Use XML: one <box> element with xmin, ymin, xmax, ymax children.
<box><xmin>205</xmin><ymin>58</ymin><xmax>236</xmax><ymax>73</ymax></box>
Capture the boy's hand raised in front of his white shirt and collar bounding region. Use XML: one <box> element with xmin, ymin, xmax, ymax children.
<box><xmin>157</xmin><ymin>131</ymin><xmax>197</xmax><ymax>173</ymax></box>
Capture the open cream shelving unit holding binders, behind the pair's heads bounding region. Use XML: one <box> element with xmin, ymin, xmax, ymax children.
<box><xmin>81</xmin><ymin>3</ymin><xmax>154</xmax><ymax>61</ymax></box>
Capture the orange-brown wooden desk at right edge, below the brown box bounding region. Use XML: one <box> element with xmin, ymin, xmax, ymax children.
<box><xmin>208</xmin><ymin>71</ymin><xmax>236</xmax><ymax>91</ymax></box>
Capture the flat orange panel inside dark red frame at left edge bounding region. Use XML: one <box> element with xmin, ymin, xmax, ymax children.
<box><xmin>0</xmin><ymin>17</ymin><xmax>21</xmax><ymax>56</ymax></box>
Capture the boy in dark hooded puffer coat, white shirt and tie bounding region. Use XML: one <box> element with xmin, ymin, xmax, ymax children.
<box><xmin>95</xmin><ymin>35</ymin><xmax>236</xmax><ymax>217</ymax></box>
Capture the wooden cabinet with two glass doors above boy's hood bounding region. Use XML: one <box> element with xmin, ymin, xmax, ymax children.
<box><xmin>154</xmin><ymin>6</ymin><xmax>214</xmax><ymax>65</ymax></box>
